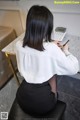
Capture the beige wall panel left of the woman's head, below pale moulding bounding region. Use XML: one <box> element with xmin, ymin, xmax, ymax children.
<box><xmin>0</xmin><ymin>9</ymin><xmax>23</xmax><ymax>36</ymax></box>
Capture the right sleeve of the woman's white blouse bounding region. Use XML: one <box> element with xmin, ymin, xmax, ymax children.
<box><xmin>53</xmin><ymin>48</ymin><xmax>79</xmax><ymax>75</ymax></box>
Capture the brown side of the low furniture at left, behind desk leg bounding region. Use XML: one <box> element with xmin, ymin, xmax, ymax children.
<box><xmin>0</xmin><ymin>51</ymin><xmax>17</xmax><ymax>89</ymax></box>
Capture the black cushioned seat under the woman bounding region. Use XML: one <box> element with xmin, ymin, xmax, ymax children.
<box><xmin>8</xmin><ymin>99</ymin><xmax>66</xmax><ymax>120</ymax></box>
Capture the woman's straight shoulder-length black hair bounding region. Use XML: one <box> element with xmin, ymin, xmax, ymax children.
<box><xmin>23</xmin><ymin>5</ymin><xmax>53</xmax><ymax>51</ymax></box>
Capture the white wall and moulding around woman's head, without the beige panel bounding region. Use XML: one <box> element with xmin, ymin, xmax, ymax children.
<box><xmin>0</xmin><ymin>0</ymin><xmax>80</xmax><ymax>36</ymax></box>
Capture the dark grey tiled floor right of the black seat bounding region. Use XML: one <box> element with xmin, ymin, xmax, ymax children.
<box><xmin>58</xmin><ymin>74</ymin><xmax>80</xmax><ymax>120</ymax></box>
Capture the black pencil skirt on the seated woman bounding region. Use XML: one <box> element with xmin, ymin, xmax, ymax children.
<box><xmin>16</xmin><ymin>80</ymin><xmax>56</xmax><ymax>115</ymax></box>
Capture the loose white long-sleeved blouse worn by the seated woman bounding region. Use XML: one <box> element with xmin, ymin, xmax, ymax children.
<box><xmin>16</xmin><ymin>41</ymin><xmax>79</xmax><ymax>84</ymax></box>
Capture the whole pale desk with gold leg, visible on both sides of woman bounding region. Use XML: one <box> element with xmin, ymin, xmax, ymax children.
<box><xmin>2</xmin><ymin>33</ymin><xmax>80</xmax><ymax>85</ymax></box>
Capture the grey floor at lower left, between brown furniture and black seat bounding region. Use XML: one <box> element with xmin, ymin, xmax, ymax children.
<box><xmin>0</xmin><ymin>78</ymin><xmax>18</xmax><ymax>112</ymax></box>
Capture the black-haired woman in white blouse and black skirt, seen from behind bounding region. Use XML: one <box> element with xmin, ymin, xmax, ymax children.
<box><xmin>16</xmin><ymin>5</ymin><xmax>79</xmax><ymax>115</ymax></box>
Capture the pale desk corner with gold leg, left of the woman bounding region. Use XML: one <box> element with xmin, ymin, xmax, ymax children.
<box><xmin>2</xmin><ymin>33</ymin><xmax>24</xmax><ymax>85</ymax></box>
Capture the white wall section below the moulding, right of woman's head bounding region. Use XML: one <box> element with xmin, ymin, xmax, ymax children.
<box><xmin>53</xmin><ymin>13</ymin><xmax>80</xmax><ymax>36</ymax></box>
